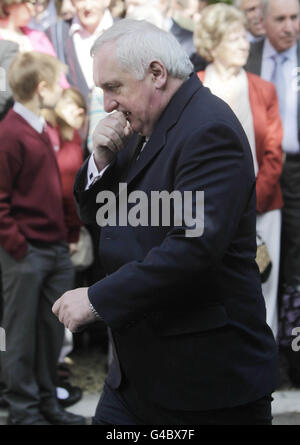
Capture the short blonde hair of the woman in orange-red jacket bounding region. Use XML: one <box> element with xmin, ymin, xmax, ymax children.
<box><xmin>194</xmin><ymin>3</ymin><xmax>246</xmax><ymax>62</ymax></box>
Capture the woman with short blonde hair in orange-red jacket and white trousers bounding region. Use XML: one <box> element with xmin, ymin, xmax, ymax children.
<box><xmin>195</xmin><ymin>3</ymin><xmax>283</xmax><ymax>338</ymax></box>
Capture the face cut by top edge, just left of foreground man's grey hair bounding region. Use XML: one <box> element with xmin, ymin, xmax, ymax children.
<box><xmin>73</xmin><ymin>0</ymin><xmax>108</xmax><ymax>33</ymax></box>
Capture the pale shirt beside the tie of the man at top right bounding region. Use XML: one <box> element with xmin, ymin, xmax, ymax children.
<box><xmin>261</xmin><ymin>39</ymin><xmax>299</xmax><ymax>153</ymax></box>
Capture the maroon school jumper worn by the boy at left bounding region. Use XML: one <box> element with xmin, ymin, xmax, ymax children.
<box><xmin>0</xmin><ymin>110</ymin><xmax>66</xmax><ymax>260</ymax></box>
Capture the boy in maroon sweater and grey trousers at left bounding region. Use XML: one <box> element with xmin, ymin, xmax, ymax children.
<box><xmin>0</xmin><ymin>52</ymin><xmax>84</xmax><ymax>425</ymax></box>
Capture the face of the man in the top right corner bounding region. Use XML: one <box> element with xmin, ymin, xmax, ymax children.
<box><xmin>265</xmin><ymin>0</ymin><xmax>299</xmax><ymax>52</ymax></box>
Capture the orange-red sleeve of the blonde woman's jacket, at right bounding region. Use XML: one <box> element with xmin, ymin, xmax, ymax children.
<box><xmin>256</xmin><ymin>84</ymin><xmax>283</xmax><ymax>213</ymax></box>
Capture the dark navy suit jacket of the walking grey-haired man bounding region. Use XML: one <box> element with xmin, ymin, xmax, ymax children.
<box><xmin>74</xmin><ymin>74</ymin><xmax>277</xmax><ymax>410</ymax></box>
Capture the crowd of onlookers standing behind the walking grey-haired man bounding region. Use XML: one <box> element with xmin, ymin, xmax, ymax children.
<box><xmin>0</xmin><ymin>0</ymin><xmax>300</xmax><ymax>424</ymax></box>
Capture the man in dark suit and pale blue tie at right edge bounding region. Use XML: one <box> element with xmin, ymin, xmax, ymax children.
<box><xmin>246</xmin><ymin>0</ymin><xmax>300</xmax><ymax>386</ymax></box>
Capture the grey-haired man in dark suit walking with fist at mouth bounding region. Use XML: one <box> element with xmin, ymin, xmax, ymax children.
<box><xmin>53</xmin><ymin>19</ymin><xmax>277</xmax><ymax>425</ymax></box>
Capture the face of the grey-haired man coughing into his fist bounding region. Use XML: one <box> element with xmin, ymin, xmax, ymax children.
<box><xmin>94</xmin><ymin>43</ymin><xmax>162</xmax><ymax>136</ymax></box>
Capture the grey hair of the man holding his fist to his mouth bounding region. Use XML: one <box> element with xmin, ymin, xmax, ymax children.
<box><xmin>91</xmin><ymin>19</ymin><xmax>194</xmax><ymax>80</ymax></box>
